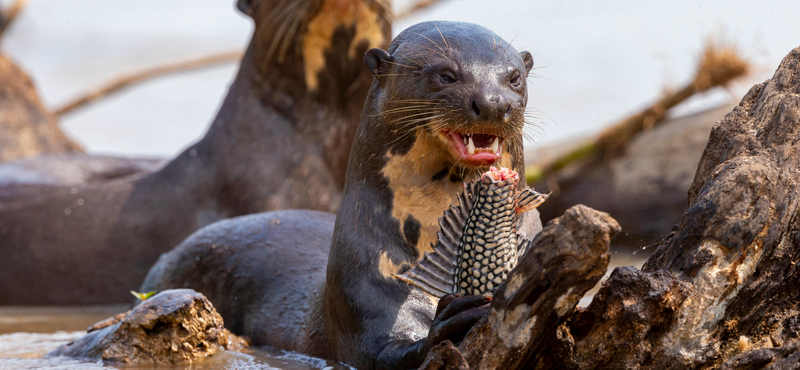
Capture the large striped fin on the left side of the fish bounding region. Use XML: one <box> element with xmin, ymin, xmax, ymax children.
<box><xmin>392</xmin><ymin>181</ymin><xmax>480</xmax><ymax>297</ymax></box>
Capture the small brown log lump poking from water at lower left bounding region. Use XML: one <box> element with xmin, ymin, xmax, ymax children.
<box><xmin>49</xmin><ymin>289</ymin><xmax>246</xmax><ymax>366</ymax></box>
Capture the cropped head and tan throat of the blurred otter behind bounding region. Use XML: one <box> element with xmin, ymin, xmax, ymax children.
<box><xmin>238</xmin><ymin>0</ymin><xmax>391</xmax><ymax>107</ymax></box>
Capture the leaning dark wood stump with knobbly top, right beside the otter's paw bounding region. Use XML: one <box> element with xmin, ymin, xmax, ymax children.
<box><xmin>450</xmin><ymin>205</ymin><xmax>619</xmax><ymax>369</ymax></box>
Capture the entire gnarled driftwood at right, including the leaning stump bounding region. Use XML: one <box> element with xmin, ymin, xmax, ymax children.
<box><xmin>418</xmin><ymin>48</ymin><xmax>800</xmax><ymax>369</ymax></box>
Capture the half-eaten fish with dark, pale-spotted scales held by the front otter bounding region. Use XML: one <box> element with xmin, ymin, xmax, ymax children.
<box><xmin>392</xmin><ymin>166</ymin><xmax>550</xmax><ymax>298</ymax></box>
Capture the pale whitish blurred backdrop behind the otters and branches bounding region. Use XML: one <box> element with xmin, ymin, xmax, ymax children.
<box><xmin>2</xmin><ymin>0</ymin><xmax>800</xmax><ymax>157</ymax></box>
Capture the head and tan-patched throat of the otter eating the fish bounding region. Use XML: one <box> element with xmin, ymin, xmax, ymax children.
<box><xmin>354</xmin><ymin>22</ymin><xmax>533</xmax><ymax>266</ymax></box>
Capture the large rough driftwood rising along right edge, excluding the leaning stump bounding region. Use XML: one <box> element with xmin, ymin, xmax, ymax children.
<box><xmin>536</xmin><ymin>44</ymin><xmax>800</xmax><ymax>369</ymax></box>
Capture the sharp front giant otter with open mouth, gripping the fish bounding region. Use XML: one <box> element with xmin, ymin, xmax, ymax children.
<box><xmin>141</xmin><ymin>22</ymin><xmax>541</xmax><ymax>369</ymax></box>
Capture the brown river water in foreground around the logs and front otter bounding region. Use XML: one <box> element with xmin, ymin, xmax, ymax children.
<box><xmin>0</xmin><ymin>249</ymin><xmax>652</xmax><ymax>370</ymax></box>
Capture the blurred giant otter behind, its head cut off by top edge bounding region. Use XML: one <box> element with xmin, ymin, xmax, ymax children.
<box><xmin>0</xmin><ymin>0</ymin><xmax>391</xmax><ymax>305</ymax></box>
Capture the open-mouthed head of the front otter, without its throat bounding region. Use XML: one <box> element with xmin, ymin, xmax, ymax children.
<box><xmin>365</xmin><ymin>22</ymin><xmax>533</xmax><ymax>177</ymax></box>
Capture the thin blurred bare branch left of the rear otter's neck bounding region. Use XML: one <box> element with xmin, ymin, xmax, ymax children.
<box><xmin>55</xmin><ymin>51</ymin><xmax>243</xmax><ymax>116</ymax></box>
